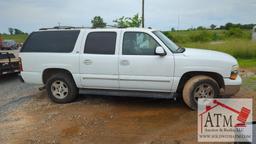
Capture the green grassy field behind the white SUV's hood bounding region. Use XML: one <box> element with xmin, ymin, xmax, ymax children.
<box><xmin>168</xmin><ymin>29</ymin><xmax>256</xmax><ymax>69</ymax></box>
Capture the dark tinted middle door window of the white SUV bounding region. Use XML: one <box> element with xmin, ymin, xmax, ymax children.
<box><xmin>84</xmin><ymin>32</ymin><xmax>116</xmax><ymax>55</ymax></box>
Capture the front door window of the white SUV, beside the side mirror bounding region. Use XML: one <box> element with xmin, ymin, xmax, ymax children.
<box><xmin>122</xmin><ymin>32</ymin><xmax>159</xmax><ymax>55</ymax></box>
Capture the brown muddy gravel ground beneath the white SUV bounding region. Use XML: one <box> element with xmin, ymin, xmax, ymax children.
<box><xmin>0</xmin><ymin>73</ymin><xmax>256</xmax><ymax>144</ymax></box>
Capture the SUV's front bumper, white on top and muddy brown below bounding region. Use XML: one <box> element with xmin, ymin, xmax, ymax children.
<box><xmin>220</xmin><ymin>76</ymin><xmax>242</xmax><ymax>96</ymax></box>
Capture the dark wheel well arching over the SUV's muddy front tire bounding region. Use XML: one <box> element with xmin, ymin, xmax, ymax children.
<box><xmin>177</xmin><ymin>72</ymin><xmax>225</xmax><ymax>94</ymax></box>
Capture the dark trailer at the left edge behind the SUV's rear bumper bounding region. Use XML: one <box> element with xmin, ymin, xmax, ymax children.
<box><xmin>0</xmin><ymin>51</ymin><xmax>21</xmax><ymax>76</ymax></box>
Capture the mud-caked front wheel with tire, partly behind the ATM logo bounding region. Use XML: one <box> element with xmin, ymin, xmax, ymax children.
<box><xmin>182</xmin><ymin>75</ymin><xmax>220</xmax><ymax>110</ymax></box>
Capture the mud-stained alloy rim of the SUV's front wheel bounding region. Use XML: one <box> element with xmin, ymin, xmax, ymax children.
<box><xmin>194</xmin><ymin>83</ymin><xmax>215</xmax><ymax>102</ymax></box>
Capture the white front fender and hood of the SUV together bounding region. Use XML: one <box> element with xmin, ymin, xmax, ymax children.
<box><xmin>174</xmin><ymin>48</ymin><xmax>237</xmax><ymax>77</ymax></box>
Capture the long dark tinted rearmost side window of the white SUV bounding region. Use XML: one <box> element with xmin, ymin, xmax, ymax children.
<box><xmin>21</xmin><ymin>31</ymin><xmax>80</xmax><ymax>53</ymax></box>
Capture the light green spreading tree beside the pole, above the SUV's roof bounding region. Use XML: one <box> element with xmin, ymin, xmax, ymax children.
<box><xmin>113</xmin><ymin>14</ymin><xmax>142</xmax><ymax>28</ymax></box>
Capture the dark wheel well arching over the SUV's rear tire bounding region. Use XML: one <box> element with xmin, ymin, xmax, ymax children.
<box><xmin>42</xmin><ymin>68</ymin><xmax>74</xmax><ymax>84</ymax></box>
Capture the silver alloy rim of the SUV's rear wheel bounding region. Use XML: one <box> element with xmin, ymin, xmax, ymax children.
<box><xmin>51</xmin><ymin>80</ymin><xmax>68</xmax><ymax>99</ymax></box>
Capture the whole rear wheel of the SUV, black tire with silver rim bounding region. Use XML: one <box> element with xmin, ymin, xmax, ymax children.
<box><xmin>46</xmin><ymin>73</ymin><xmax>78</xmax><ymax>103</ymax></box>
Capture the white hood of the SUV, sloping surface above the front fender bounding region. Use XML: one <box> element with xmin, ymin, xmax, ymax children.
<box><xmin>183</xmin><ymin>48</ymin><xmax>237</xmax><ymax>65</ymax></box>
